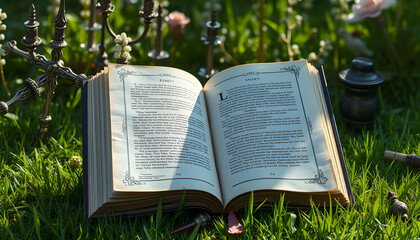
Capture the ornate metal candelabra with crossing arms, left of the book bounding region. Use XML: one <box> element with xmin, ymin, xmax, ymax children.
<box><xmin>0</xmin><ymin>0</ymin><xmax>88</xmax><ymax>140</ymax></box>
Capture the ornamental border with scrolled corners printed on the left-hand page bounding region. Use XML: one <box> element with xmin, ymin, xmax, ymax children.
<box><xmin>117</xmin><ymin>68</ymin><xmax>215</xmax><ymax>187</ymax></box>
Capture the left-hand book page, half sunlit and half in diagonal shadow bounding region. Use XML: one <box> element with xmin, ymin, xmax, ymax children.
<box><xmin>109</xmin><ymin>64</ymin><xmax>221</xmax><ymax>199</ymax></box>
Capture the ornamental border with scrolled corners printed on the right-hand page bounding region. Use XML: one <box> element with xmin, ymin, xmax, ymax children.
<box><xmin>221</xmin><ymin>65</ymin><xmax>328</xmax><ymax>187</ymax></box>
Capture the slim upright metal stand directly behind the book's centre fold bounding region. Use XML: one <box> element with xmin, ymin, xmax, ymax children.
<box><xmin>198</xmin><ymin>10</ymin><xmax>221</xmax><ymax>79</ymax></box>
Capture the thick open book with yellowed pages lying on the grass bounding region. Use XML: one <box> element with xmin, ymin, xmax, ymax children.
<box><xmin>83</xmin><ymin>60</ymin><xmax>353</xmax><ymax>217</ymax></box>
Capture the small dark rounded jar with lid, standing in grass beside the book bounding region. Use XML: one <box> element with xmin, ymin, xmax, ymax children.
<box><xmin>338</xmin><ymin>57</ymin><xmax>385</xmax><ymax>127</ymax></box>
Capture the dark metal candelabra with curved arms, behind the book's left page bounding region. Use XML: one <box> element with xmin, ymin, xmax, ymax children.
<box><xmin>95</xmin><ymin>0</ymin><xmax>158</xmax><ymax>69</ymax></box>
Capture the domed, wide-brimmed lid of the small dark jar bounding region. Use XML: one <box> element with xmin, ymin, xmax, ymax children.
<box><xmin>338</xmin><ymin>57</ymin><xmax>385</xmax><ymax>86</ymax></box>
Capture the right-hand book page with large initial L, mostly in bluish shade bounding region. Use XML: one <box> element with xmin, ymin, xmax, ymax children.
<box><xmin>204</xmin><ymin>61</ymin><xmax>337</xmax><ymax>204</ymax></box>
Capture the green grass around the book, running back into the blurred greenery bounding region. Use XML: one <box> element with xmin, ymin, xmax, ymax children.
<box><xmin>0</xmin><ymin>0</ymin><xmax>420</xmax><ymax>239</ymax></box>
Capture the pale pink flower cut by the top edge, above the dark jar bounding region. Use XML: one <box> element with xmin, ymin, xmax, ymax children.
<box><xmin>347</xmin><ymin>0</ymin><xmax>396</xmax><ymax>23</ymax></box>
